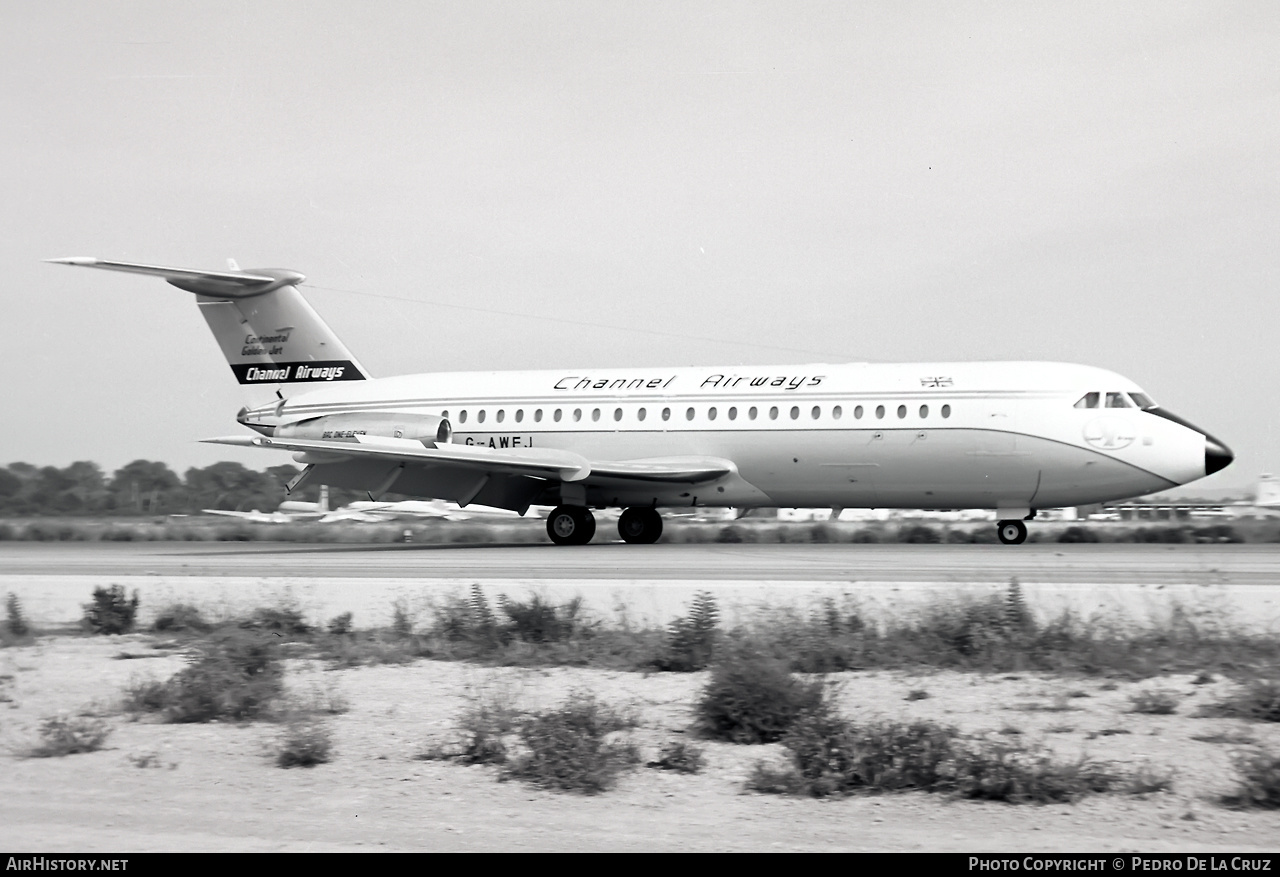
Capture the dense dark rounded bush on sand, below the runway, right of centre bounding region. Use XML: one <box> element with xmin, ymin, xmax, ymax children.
<box><xmin>695</xmin><ymin>647</ymin><xmax>826</xmax><ymax>743</ymax></box>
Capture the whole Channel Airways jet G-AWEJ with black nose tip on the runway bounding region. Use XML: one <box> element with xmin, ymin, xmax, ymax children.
<box><xmin>49</xmin><ymin>257</ymin><xmax>1234</xmax><ymax>545</ymax></box>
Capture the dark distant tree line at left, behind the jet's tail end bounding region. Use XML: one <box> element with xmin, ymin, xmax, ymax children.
<box><xmin>0</xmin><ymin>460</ymin><xmax>366</xmax><ymax>517</ymax></box>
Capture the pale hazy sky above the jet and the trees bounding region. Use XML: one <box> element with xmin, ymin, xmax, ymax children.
<box><xmin>0</xmin><ymin>0</ymin><xmax>1280</xmax><ymax>492</ymax></box>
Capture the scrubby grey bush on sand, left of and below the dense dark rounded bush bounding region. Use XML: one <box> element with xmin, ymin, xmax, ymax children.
<box><xmin>503</xmin><ymin>691</ymin><xmax>639</xmax><ymax>795</ymax></box>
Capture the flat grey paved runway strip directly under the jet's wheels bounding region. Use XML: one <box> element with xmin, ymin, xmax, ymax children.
<box><xmin>0</xmin><ymin>542</ymin><xmax>1280</xmax><ymax>585</ymax></box>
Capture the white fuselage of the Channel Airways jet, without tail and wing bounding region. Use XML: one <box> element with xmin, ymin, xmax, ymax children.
<box><xmin>246</xmin><ymin>362</ymin><xmax>1206</xmax><ymax>513</ymax></box>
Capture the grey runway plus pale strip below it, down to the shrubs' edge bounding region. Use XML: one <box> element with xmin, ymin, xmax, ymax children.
<box><xmin>0</xmin><ymin>543</ymin><xmax>1280</xmax><ymax>631</ymax></box>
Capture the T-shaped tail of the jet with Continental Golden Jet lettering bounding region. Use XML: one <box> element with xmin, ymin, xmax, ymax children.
<box><xmin>47</xmin><ymin>257</ymin><xmax>370</xmax><ymax>384</ymax></box>
